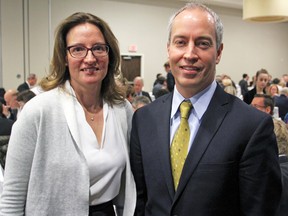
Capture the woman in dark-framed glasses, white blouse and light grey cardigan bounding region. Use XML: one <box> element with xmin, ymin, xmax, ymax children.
<box><xmin>0</xmin><ymin>13</ymin><xmax>136</xmax><ymax>216</ymax></box>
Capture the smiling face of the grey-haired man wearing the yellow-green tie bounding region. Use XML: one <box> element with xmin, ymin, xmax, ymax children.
<box><xmin>167</xmin><ymin>9</ymin><xmax>223</xmax><ymax>98</ymax></box>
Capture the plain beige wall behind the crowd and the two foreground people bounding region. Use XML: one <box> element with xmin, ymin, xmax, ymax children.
<box><xmin>0</xmin><ymin>0</ymin><xmax>288</xmax><ymax>91</ymax></box>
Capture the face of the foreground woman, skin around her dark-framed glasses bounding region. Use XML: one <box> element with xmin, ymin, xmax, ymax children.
<box><xmin>66</xmin><ymin>23</ymin><xmax>109</xmax><ymax>90</ymax></box>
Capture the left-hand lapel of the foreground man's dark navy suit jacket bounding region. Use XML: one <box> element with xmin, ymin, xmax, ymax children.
<box><xmin>155</xmin><ymin>93</ymin><xmax>175</xmax><ymax>200</ymax></box>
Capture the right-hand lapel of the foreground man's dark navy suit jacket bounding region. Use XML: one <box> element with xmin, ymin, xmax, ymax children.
<box><xmin>174</xmin><ymin>86</ymin><xmax>229</xmax><ymax>201</ymax></box>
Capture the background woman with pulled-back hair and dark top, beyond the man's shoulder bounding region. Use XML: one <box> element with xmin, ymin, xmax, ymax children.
<box><xmin>243</xmin><ymin>69</ymin><xmax>269</xmax><ymax>104</ymax></box>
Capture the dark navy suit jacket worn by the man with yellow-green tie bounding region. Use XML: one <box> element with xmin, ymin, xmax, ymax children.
<box><xmin>130</xmin><ymin>86</ymin><xmax>281</xmax><ymax>216</ymax></box>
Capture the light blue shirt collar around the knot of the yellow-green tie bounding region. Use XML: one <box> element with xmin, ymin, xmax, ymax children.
<box><xmin>170</xmin><ymin>80</ymin><xmax>217</xmax><ymax>120</ymax></box>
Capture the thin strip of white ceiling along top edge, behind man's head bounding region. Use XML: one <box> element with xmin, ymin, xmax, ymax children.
<box><xmin>118</xmin><ymin>0</ymin><xmax>243</xmax><ymax>9</ymax></box>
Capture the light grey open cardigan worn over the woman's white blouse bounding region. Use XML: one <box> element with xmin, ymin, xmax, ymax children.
<box><xmin>0</xmin><ymin>81</ymin><xmax>136</xmax><ymax>216</ymax></box>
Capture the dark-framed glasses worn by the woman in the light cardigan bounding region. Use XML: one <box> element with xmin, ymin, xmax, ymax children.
<box><xmin>67</xmin><ymin>44</ymin><xmax>109</xmax><ymax>59</ymax></box>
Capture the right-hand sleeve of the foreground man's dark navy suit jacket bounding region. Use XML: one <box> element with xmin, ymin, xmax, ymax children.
<box><xmin>239</xmin><ymin>116</ymin><xmax>281</xmax><ymax>216</ymax></box>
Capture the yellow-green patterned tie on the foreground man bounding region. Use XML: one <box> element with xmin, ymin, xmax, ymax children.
<box><xmin>170</xmin><ymin>101</ymin><xmax>192</xmax><ymax>190</ymax></box>
